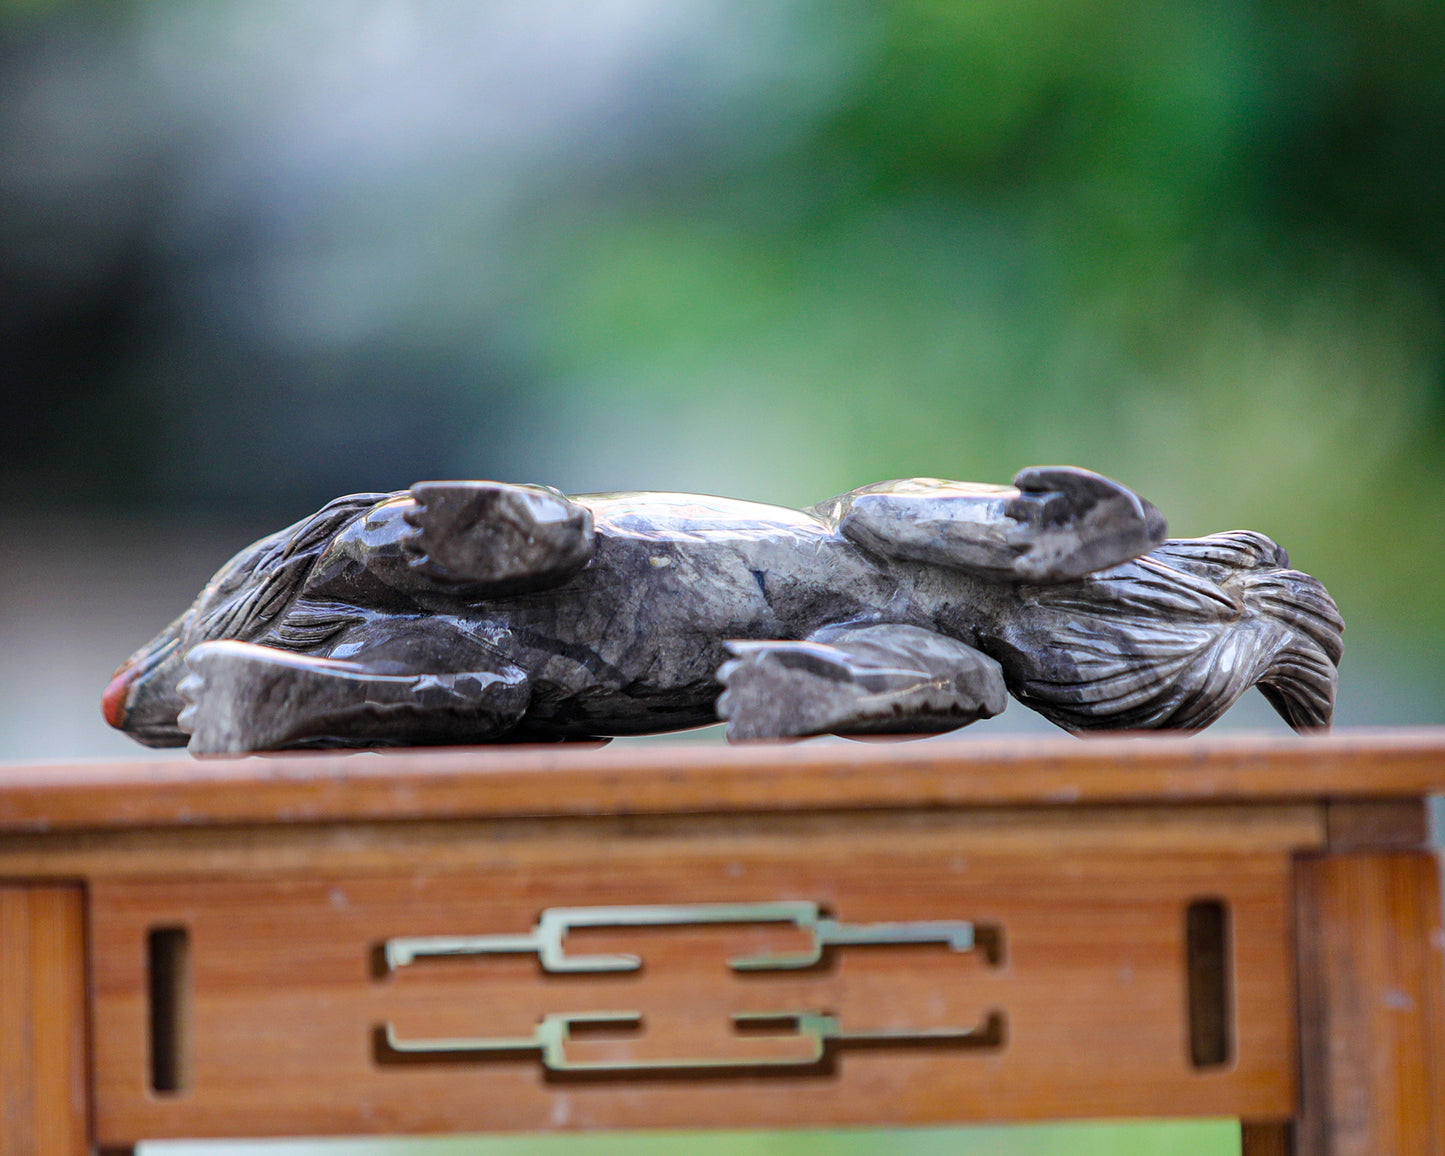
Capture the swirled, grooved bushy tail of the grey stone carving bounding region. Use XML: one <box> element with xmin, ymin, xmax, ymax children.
<box><xmin>984</xmin><ymin>530</ymin><xmax>1344</xmax><ymax>731</ymax></box>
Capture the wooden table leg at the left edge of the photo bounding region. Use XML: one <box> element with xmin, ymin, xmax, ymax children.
<box><xmin>0</xmin><ymin>884</ymin><xmax>90</xmax><ymax>1156</ymax></box>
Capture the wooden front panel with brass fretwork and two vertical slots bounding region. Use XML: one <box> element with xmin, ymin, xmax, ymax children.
<box><xmin>91</xmin><ymin>832</ymin><xmax>1295</xmax><ymax>1146</ymax></box>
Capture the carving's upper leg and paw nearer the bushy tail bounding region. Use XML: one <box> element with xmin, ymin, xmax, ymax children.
<box><xmin>816</xmin><ymin>465</ymin><xmax>1166</xmax><ymax>582</ymax></box>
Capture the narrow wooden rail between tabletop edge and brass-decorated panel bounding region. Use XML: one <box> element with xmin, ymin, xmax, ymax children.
<box><xmin>0</xmin><ymin>803</ymin><xmax>1325</xmax><ymax>880</ymax></box>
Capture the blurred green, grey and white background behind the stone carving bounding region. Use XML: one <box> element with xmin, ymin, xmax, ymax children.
<box><xmin>0</xmin><ymin>0</ymin><xmax>1445</xmax><ymax>1153</ymax></box>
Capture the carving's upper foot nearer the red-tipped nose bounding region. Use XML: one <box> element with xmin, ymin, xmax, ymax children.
<box><xmin>403</xmin><ymin>481</ymin><xmax>595</xmax><ymax>597</ymax></box>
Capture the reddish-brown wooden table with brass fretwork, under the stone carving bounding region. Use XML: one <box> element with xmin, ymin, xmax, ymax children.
<box><xmin>0</xmin><ymin>728</ymin><xmax>1445</xmax><ymax>1156</ymax></box>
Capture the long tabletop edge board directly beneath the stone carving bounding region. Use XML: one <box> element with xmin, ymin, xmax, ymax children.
<box><xmin>0</xmin><ymin>727</ymin><xmax>1445</xmax><ymax>831</ymax></box>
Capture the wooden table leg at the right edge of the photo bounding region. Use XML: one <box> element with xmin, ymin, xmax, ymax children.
<box><xmin>1298</xmin><ymin>851</ymin><xmax>1445</xmax><ymax>1156</ymax></box>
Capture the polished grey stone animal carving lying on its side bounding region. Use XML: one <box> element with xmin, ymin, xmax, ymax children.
<box><xmin>103</xmin><ymin>467</ymin><xmax>1342</xmax><ymax>754</ymax></box>
